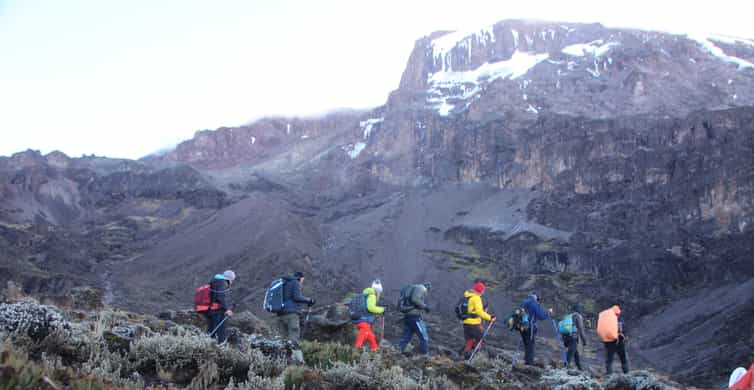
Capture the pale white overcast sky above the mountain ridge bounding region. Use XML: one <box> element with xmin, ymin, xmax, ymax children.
<box><xmin>0</xmin><ymin>0</ymin><xmax>754</xmax><ymax>158</ymax></box>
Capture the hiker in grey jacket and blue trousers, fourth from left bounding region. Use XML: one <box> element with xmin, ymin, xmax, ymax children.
<box><xmin>399</xmin><ymin>282</ymin><xmax>432</xmax><ymax>355</ymax></box>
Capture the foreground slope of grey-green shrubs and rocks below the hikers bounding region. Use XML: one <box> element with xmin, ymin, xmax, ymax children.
<box><xmin>0</xmin><ymin>292</ymin><xmax>687</xmax><ymax>390</ymax></box>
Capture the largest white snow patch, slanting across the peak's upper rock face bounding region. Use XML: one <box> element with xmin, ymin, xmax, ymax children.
<box><xmin>427</xmin><ymin>50</ymin><xmax>549</xmax><ymax>116</ymax></box>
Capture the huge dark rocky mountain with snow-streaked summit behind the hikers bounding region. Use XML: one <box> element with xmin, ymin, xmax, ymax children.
<box><xmin>0</xmin><ymin>20</ymin><xmax>754</xmax><ymax>386</ymax></box>
